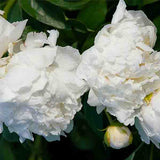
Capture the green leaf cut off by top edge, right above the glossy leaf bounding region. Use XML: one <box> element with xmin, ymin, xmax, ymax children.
<box><xmin>47</xmin><ymin>0</ymin><xmax>90</xmax><ymax>10</ymax></box>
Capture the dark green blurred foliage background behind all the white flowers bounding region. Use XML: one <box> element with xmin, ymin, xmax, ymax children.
<box><xmin>0</xmin><ymin>0</ymin><xmax>160</xmax><ymax>160</ymax></box>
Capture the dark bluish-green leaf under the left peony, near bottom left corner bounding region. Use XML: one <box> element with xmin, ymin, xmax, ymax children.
<box><xmin>2</xmin><ymin>126</ymin><xmax>19</xmax><ymax>142</ymax></box>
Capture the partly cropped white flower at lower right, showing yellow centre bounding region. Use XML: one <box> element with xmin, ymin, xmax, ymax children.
<box><xmin>135</xmin><ymin>90</ymin><xmax>160</xmax><ymax>148</ymax></box>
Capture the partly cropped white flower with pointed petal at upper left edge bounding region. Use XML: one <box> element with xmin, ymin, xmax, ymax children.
<box><xmin>0</xmin><ymin>11</ymin><xmax>27</xmax><ymax>58</ymax></box>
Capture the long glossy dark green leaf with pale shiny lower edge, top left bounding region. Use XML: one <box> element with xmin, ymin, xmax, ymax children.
<box><xmin>20</xmin><ymin>0</ymin><xmax>67</xmax><ymax>29</ymax></box>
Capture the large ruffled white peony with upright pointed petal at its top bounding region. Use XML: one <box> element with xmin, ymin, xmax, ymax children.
<box><xmin>77</xmin><ymin>0</ymin><xmax>160</xmax><ymax>125</ymax></box>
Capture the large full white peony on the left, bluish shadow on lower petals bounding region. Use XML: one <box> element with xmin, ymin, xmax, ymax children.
<box><xmin>0</xmin><ymin>30</ymin><xmax>87</xmax><ymax>142</ymax></box>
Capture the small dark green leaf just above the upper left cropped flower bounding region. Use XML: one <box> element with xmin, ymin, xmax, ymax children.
<box><xmin>7</xmin><ymin>2</ymin><xmax>23</xmax><ymax>22</ymax></box>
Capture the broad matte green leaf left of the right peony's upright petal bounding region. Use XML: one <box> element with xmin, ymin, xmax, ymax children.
<box><xmin>77</xmin><ymin>0</ymin><xmax>107</xmax><ymax>29</ymax></box>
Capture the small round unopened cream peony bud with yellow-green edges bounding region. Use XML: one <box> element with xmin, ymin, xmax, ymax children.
<box><xmin>104</xmin><ymin>126</ymin><xmax>133</xmax><ymax>149</ymax></box>
